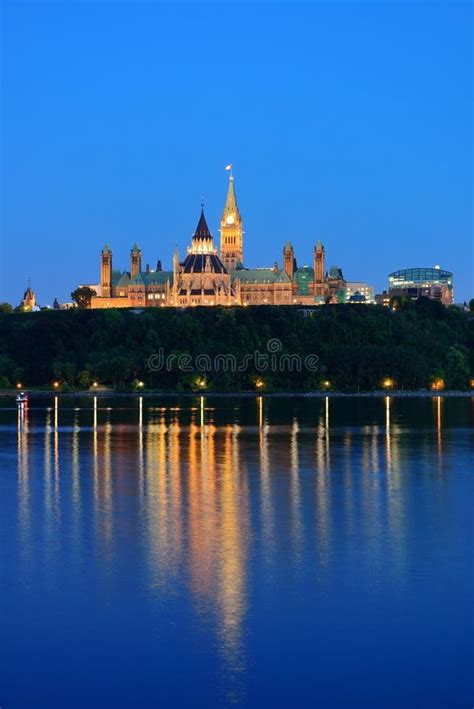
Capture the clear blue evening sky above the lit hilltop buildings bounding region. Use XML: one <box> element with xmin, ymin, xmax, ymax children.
<box><xmin>0</xmin><ymin>0</ymin><xmax>474</xmax><ymax>304</ymax></box>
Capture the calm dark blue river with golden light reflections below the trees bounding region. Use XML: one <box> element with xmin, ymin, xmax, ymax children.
<box><xmin>0</xmin><ymin>397</ymin><xmax>474</xmax><ymax>709</ymax></box>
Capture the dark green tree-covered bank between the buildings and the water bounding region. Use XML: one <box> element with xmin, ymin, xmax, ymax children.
<box><xmin>0</xmin><ymin>298</ymin><xmax>474</xmax><ymax>392</ymax></box>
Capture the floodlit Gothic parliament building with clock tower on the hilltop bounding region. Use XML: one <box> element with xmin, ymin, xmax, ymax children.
<box><xmin>86</xmin><ymin>174</ymin><xmax>346</xmax><ymax>308</ymax></box>
